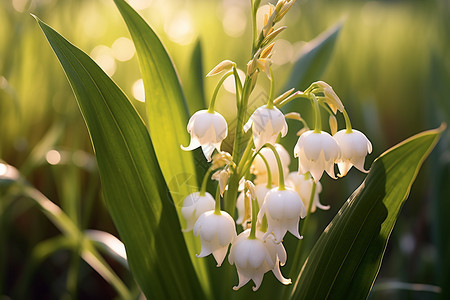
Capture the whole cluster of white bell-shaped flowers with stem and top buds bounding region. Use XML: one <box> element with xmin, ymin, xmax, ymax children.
<box><xmin>181</xmin><ymin>0</ymin><xmax>372</xmax><ymax>290</ymax></box>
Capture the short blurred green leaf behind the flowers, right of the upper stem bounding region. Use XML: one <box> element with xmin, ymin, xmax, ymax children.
<box><xmin>284</xmin><ymin>22</ymin><xmax>342</xmax><ymax>90</ymax></box>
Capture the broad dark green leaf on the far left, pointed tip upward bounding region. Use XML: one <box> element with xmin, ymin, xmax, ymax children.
<box><xmin>38</xmin><ymin>20</ymin><xmax>204</xmax><ymax>299</ymax></box>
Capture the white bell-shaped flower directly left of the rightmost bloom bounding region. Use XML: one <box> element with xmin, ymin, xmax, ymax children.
<box><xmin>294</xmin><ymin>130</ymin><xmax>341</xmax><ymax>183</ymax></box>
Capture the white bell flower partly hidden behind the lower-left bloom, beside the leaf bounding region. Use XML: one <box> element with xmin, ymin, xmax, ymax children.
<box><xmin>181</xmin><ymin>192</ymin><xmax>215</xmax><ymax>232</ymax></box>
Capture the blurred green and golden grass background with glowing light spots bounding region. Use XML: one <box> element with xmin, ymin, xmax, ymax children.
<box><xmin>0</xmin><ymin>0</ymin><xmax>450</xmax><ymax>299</ymax></box>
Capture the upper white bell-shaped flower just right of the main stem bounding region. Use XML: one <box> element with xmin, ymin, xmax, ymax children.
<box><xmin>244</xmin><ymin>105</ymin><xmax>288</xmax><ymax>150</ymax></box>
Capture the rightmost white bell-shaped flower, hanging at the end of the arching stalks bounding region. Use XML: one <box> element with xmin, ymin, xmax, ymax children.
<box><xmin>333</xmin><ymin>129</ymin><xmax>372</xmax><ymax>177</ymax></box>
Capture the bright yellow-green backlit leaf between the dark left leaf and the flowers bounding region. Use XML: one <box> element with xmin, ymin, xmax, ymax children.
<box><xmin>114</xmin><ymin>0</ymin><xmax>209</xmax><ymax>293</ymax></box>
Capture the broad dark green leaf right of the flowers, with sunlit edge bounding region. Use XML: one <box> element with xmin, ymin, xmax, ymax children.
<box><xmin>292</xmin><ymin>127</ymin><xmax>444</xmax><ymax>299</ymax></box>
